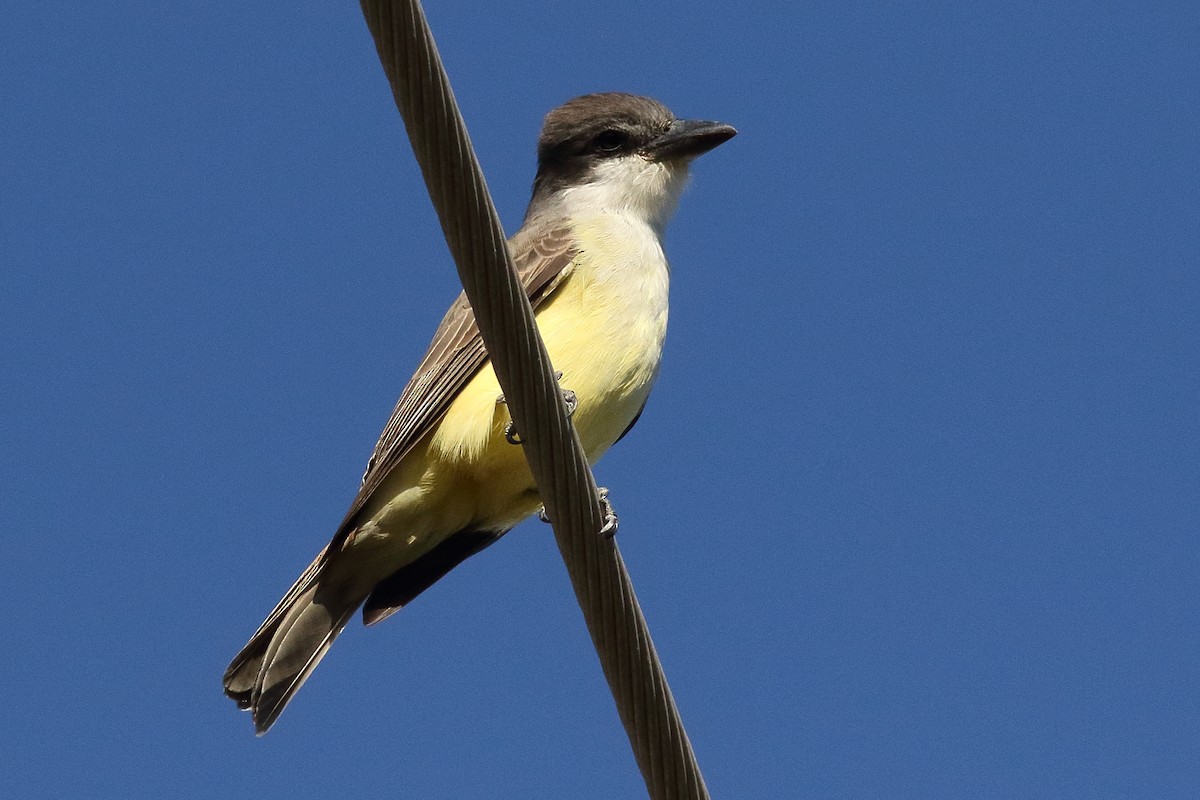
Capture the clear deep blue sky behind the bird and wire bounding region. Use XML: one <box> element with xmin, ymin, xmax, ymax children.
<box><xmin>0</xmin><ymin>0</ymin><xmax>1200</xmax><ymax>800</ymax></box>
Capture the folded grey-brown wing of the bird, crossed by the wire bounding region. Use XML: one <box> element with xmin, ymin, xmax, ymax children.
<box><xmin>335</xmin><ymin>225</ymin><xmax>576</xmax><ymax>540</ymax></box>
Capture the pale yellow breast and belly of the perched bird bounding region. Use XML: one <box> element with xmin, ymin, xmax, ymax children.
<box><xmin>355</xmin><ymin>217</ymin><xmax>667</xmax><ymax>568</ymax></box>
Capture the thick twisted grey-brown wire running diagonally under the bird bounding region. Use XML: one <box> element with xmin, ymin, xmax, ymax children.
<box><xmin>361</xmin><ymin>0</ymin><xmax>708</xmax><ymax>800</ymax></box>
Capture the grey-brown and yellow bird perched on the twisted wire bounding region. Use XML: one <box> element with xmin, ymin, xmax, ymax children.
<box><xmin>223</xmin><ymin>92</ymin><xmax>737</xmax><ymax>735</ymax></box>
